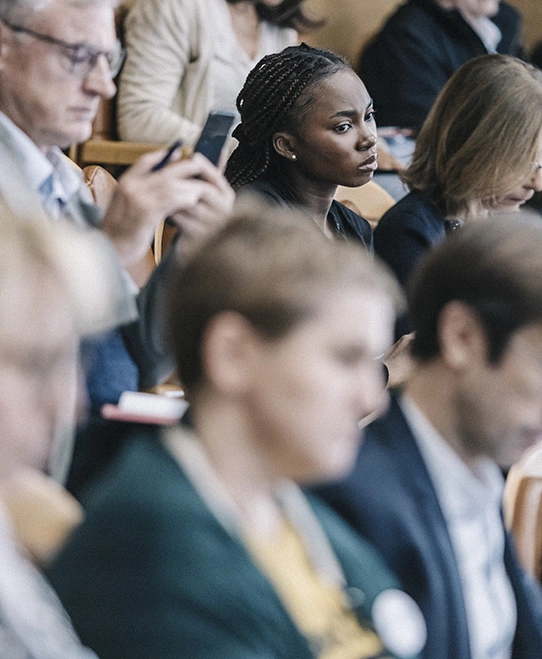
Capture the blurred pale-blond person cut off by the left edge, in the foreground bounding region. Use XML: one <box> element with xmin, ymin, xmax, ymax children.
<box><xmin>0</xmin><ymin>208</ymin><xmax>114</xmax><ymax>659</ymax></box>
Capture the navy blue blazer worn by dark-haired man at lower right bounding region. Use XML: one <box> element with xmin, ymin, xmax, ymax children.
<box><xmin>320</xmin><ymin>398</ymin><xmax>542</xmax><ymax>659</ymax></box>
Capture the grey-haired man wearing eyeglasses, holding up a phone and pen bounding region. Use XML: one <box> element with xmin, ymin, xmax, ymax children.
<box><xmin>0</xmin><ymin>0</ymin><xmax>233</xmax><ymax>464</ymax></box>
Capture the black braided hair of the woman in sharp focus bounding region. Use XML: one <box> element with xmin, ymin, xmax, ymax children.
<box><xmin>225</xmin><ymin>43</ymin><xmax>351</xmax><ymax>190</ymax></box>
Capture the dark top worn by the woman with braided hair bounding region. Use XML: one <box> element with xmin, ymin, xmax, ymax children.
<box><xmin>239</xmin><ymin>173</ymin><xmax>373</xmax><ymax>252</ymax></box>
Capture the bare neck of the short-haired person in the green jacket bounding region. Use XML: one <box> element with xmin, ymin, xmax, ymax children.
<box><xmin>192</xmin><ymin>394</ymin><xmax>280</xmax><ymax>535</ymax></box>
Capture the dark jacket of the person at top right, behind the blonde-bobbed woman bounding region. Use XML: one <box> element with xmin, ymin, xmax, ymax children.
<box><xmin>358</xmin><ymin>0</ymin><xmax>523</xmax><ymax>129</ymax></box>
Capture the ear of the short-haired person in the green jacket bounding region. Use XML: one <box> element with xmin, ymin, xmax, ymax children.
<box><xmin>201</xmin><ymin>311</ymin><xmax>262</xmax><ymax>396</ymax></box>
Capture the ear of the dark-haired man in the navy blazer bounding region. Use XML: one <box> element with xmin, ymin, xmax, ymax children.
<box><xmin>437</xmin><ymin>300</ymin><xmax>487</xmax><ymax>371</ymax></box>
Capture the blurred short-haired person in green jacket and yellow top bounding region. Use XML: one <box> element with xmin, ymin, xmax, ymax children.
<box><xmin>50</xmin><ymin>206</ymin><xmax>430</xmax><ymax>659</ymax></box>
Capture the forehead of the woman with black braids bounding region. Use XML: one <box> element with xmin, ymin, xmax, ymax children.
<box><xmin>302</xmin><ymin>69</ymin><xmax>371</xmax><ymax>117</ymax></box>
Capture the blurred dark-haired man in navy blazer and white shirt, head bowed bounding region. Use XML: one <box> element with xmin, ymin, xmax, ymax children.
<box><xmin>320</xmin><ymin>218</ymin><xmax>542</xmax><ymax>659</ymax></box>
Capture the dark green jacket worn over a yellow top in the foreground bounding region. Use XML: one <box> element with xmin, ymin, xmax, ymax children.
<box><xmin>49</xmin><ymin>431</ymin><xmax>420</xmax><ymax>659</ymax></box>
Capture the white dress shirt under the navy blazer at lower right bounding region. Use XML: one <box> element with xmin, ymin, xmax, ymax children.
<box><xmin>400</xmin><ymin>396</ymin><xmax>517</xmax><ymax>659</ymax></box>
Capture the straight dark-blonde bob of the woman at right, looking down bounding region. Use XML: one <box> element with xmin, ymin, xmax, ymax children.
<box><xmin>402</xmin><ymin>55</ymin><xmax>542</xmax><ymax>218</ymax></box>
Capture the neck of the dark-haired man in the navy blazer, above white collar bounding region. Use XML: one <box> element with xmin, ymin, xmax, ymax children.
<box><xmin>404</xmin><ymin>358</ymin><xmax>482</xmax><ymax>467</ymax></box>
